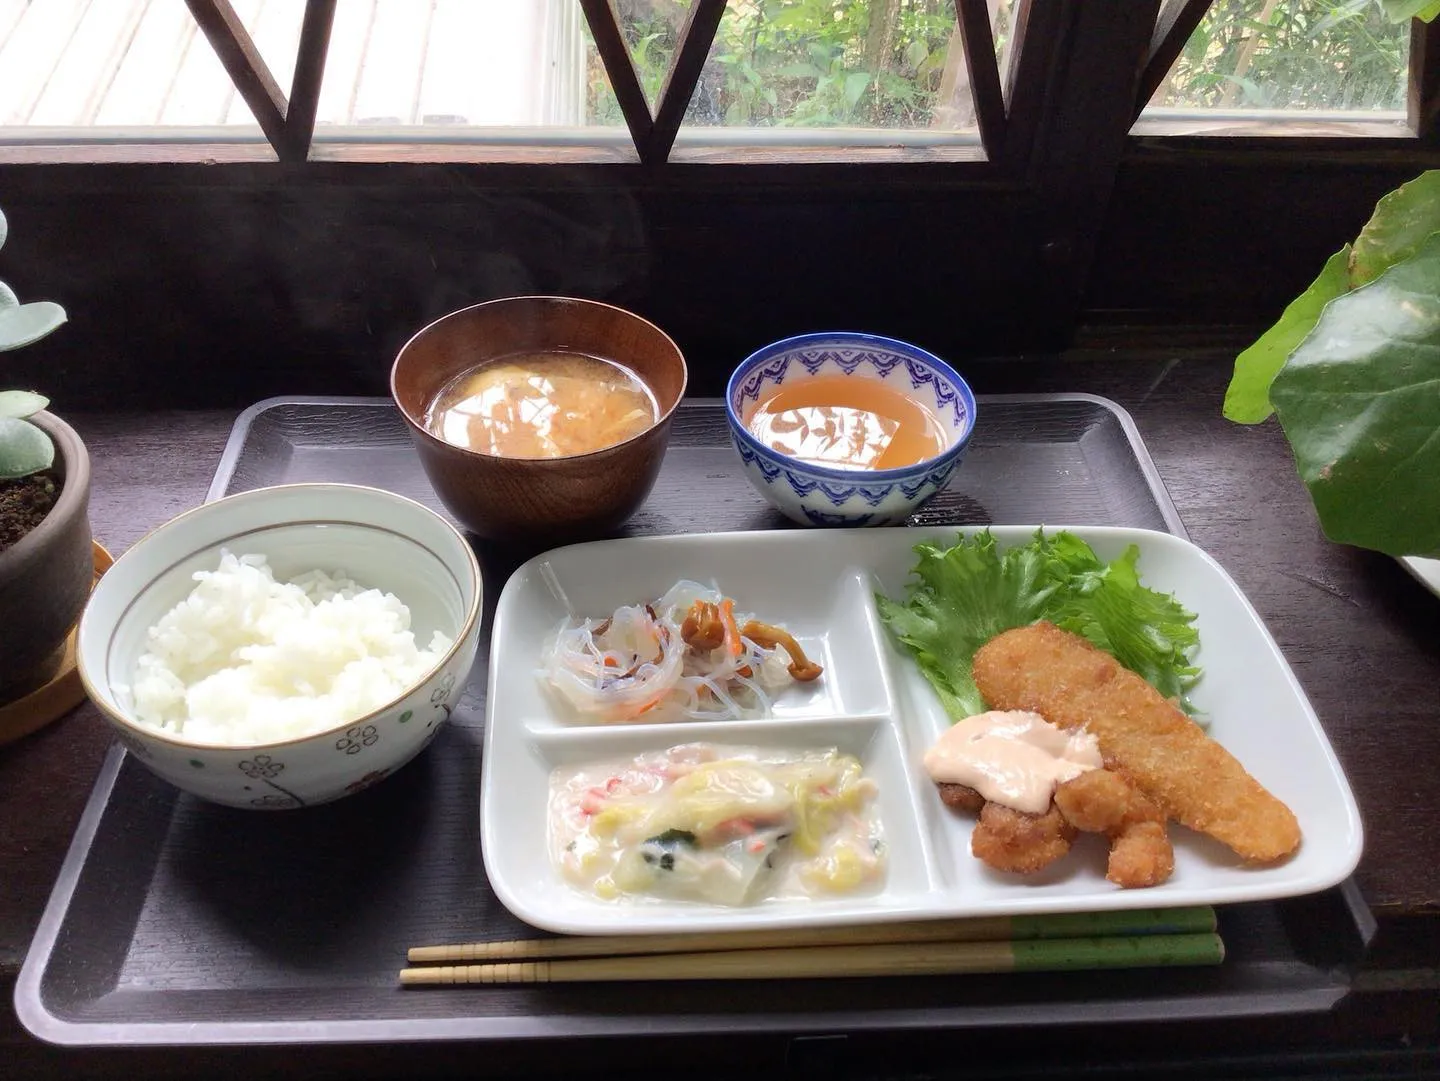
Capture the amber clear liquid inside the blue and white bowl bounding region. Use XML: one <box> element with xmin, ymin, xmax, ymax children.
<box><xmin>746</xmin><ymin>376</ymin><xmax>949</xmax><ymax>469</ymax></box>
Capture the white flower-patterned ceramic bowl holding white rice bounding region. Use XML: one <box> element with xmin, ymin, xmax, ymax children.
<box><xmin>76</xmin><ymin>484</ymin><xmax>481</xmax><ymax>809</ymax></box>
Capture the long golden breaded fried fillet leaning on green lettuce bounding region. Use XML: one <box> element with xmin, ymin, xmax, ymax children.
<box><xmin>973</xmin><ymin>623</ymin><xmax>1300</xmax><ymax>862</ymax></box>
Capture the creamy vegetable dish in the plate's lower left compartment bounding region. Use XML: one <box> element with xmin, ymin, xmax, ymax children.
<box><xmin>549</xmin><ymin>743</ymin><xmax>887</xmax><ymax>905</ymax></box>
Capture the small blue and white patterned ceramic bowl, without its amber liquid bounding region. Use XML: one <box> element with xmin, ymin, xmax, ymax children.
<box><xmin>726</xmin><ymin>331</ymin><xmax>975</xmax><ymax>525</ymax></box>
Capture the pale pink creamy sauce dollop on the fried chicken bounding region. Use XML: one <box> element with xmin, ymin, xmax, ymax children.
<box><xmin>924</xmin><ymin>710</ymin><xmax>1103</xmax><ymax>815</ymax></box>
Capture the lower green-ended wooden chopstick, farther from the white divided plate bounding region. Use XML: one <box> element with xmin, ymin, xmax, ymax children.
<box><xmin>400</xmin><ymin>933</ymin><xmax>1225</xmax><ymax>987</ymax></box>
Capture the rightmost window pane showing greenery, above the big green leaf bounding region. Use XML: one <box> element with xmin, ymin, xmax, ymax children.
<box><xmin>1146</xmin><ymin>0</ymin><xmax>1410</xmax><ymax>115</ymax></box>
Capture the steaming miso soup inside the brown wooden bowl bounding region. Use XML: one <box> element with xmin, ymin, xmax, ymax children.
<box><xmin>425</xmin><ymin>353</ymin><xmax>660</xmax><ymax>458</ymax></box>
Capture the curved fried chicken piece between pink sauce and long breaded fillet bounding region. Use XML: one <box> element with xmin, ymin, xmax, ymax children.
<box><xmin>1056</xmin><ymin>769</ymin><xmax>1175</xmax><ymax>890</ymax></box>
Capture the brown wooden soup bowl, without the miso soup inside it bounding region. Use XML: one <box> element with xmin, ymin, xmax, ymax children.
<box><xmin>390</xmin><ymin>297</ymin><xmax>687</xmax><ymax>543</ymax></box>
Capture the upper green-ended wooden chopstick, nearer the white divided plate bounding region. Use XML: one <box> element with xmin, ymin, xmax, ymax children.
<box><xmin>408</xmin><ymin>905</ymin><xmax>1215</xmax><ymax>964</ymax></box>
